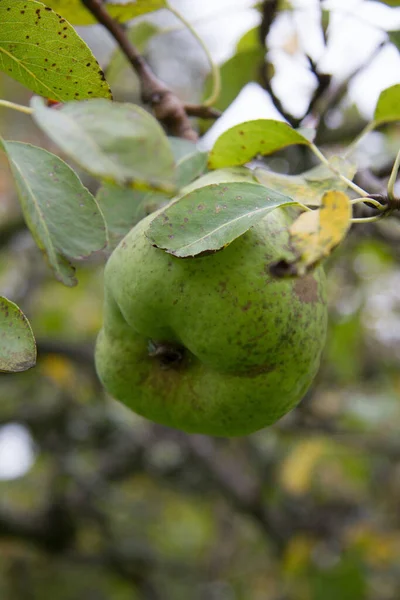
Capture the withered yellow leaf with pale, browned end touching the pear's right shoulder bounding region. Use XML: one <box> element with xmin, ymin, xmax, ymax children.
<box><xmin>290</xmin><ymin>191</ymin><xmax>351</xmax><ymax>275</ymax></box>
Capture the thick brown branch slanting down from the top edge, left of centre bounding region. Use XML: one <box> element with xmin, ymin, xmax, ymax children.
<box><xmin>81</xmin><ymin>0</ymin><xmax>198</xmax><ymax>141</ymax></box>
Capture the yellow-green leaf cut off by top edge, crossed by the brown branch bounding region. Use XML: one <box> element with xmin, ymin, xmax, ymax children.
<box><xmin>30</xmin><ymin>0</ymin><xmax>167</xmax><ymax>25</ymax></box>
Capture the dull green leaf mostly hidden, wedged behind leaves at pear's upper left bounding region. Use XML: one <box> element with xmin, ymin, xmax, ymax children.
<box><xmin>96</xmin><ymin>183</ymin><xmax>169</xmax><ymax>251</ymax></box>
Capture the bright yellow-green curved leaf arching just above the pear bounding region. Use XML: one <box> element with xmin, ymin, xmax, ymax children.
<box><xmin>208</xmin><ymin>119</ymin><xmax>310</xmax><ymax>169</ymax></box>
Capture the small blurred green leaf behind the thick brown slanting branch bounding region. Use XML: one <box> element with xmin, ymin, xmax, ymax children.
<box><xmin>106</xmin><ymin>21</ymin><xmax>160</xmax><ymax>92</ymax></box>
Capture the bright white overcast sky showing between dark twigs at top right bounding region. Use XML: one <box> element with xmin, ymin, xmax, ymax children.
<box><xmin>191</xmin><ymin>0</ymin><xmax>400</xmax><ymax>147</ymax></box>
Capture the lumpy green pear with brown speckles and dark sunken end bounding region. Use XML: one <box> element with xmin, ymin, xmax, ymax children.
<box><xmin>96</xmin><ymin>208</ymin><xmax>327</xmax><ymax>436</ymax></box>
